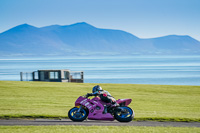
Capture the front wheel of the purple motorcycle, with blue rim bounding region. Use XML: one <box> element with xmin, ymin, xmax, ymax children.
<box><xmin>68</xmin><ymin>107</ymin><xmax>88</xmax><ymax>122</ymax></box>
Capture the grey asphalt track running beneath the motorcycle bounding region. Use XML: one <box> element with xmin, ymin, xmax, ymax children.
<box><xmin>0</xmin><ymin>119</ymin><xmax>200</xmax><ymax>127</ymax></box>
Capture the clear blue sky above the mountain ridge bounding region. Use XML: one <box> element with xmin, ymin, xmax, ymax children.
<box><xmin>0</xmin><ymin>0</ymin><xmax>200</xmax><ymax>41</ymax></box>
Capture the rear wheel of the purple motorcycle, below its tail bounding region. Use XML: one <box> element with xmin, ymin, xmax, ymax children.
<box><xmin>114</xmin><ymin>106</ymin><xmax>135</xmax><ymax>122</ymax></box>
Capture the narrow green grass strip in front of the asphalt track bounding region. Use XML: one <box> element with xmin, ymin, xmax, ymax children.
<box><xmin>0</xmin><ymin>126</ymin><xmax>200</xmax><ymax>133</ymax></box>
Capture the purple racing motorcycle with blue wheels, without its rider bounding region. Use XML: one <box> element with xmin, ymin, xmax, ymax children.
<box><xmin>68</xmin><ymin>95</ymin><xmax>135</xmax><ymax>122</ymax></box>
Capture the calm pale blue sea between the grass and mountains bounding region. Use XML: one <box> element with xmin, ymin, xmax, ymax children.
<box><xmin>0</xmin><ymin>56</ymin><xmax>200</xmax><ymax>85</ymax></box>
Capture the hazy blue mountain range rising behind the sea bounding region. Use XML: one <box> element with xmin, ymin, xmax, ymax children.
<box><xmin>0</xmin><ymin>22</ymin><xmax>200</xmax><ymax>56</ymax></box>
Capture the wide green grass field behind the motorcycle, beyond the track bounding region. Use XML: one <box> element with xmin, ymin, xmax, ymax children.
<box><xmin>0</xmin><ymin>81</ymin><xmax>200</xmax><ymax>122</ymax></box>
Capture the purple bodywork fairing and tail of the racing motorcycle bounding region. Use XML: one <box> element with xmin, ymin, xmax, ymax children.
<box><xmin>75</xmin><ymin>96</ymin><xmax>131</xmax><ymax>121</ymax></box>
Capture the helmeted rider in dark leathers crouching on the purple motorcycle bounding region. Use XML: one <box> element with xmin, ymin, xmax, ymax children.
<box><xmin>87</xmin><ymin>85</ymin><xmax>119</xmax><ymax>106</ymax></box>
